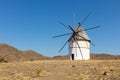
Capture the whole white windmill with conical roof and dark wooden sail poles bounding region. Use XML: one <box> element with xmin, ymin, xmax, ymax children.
<box><xmin>53</xmin><ymin>13</ymin><xmax>100</xmax><ymax>60</ymax></box>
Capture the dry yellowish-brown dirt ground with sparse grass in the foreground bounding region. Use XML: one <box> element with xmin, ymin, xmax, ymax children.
<box><xmin>0</xmin><ymin>60</ymin><xmax>120</xmax><ymax>80</ymax></box>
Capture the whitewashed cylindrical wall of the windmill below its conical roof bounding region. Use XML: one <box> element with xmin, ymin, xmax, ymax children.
<box><xmin>69</xmin><ymin>41</ymin><xmax>90</xmax><ymax>60</ymax></box>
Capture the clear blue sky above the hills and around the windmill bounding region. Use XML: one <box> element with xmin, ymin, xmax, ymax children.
<box><xmin>0</xmin><ymin>0</ymin><xmax>120</xmax><ymax>56</ymax></box>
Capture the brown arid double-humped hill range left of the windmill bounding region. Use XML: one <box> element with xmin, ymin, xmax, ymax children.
<box><xmin>0</xmin><ymin>44</ymin><xmax>48</xmax><ymax>62</ymax></box>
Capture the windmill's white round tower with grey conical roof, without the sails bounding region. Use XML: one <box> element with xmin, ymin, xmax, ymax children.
<box><xmin>68</xmin><ymin>24</ymin><xmax>90</xmax><ymax>60</ymax></box>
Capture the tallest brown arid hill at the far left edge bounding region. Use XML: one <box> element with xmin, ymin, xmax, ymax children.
<box><xmin>0</xmin><ymin>44</ymin><xmax>25</xmax><ymax>61</ymax></box>
